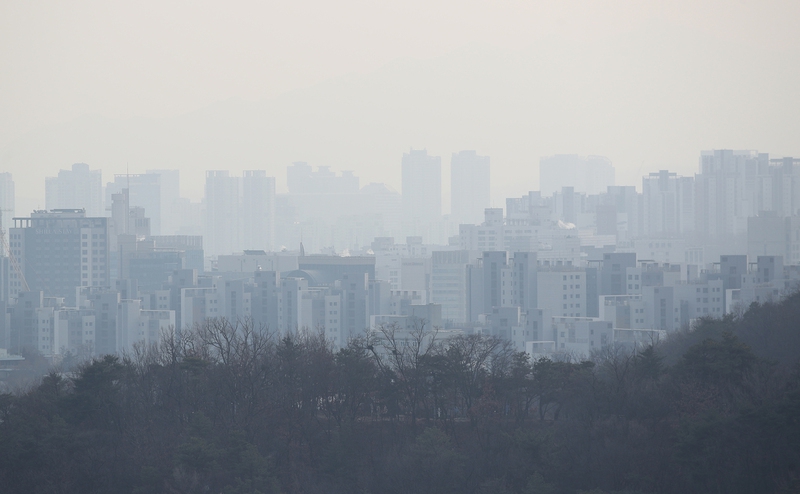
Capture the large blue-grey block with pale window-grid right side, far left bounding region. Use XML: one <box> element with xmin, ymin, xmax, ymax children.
<box><xmin>9</xmin><ymin>209</ymin><xmax>110</xmax><ymax>306</ymax></box>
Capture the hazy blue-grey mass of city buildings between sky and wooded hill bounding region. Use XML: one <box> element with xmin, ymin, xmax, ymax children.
<box><xmin>0</xmin><ymin>150</ymin><xmax>800</xmax><ymax>356</ymax></box>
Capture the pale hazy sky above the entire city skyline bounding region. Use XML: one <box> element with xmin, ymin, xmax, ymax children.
<box><xmin>0</xmin><ymin>2</ymin><xmax>800</xmax><ymax>208</ymax></box>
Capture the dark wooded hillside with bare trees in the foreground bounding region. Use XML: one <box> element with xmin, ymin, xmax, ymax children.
<box><xmin>0</xmin><ymin>295</ymin><xmax>800</xmax><ymax>494</ymax></box>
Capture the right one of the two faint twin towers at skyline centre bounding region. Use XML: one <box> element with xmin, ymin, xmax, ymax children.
<box><xmin>450</xmin><ymin>151</ymin><xmax>491</xmax><ymax>224</ymax></box>
